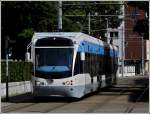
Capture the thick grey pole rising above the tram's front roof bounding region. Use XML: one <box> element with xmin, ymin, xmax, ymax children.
<box><xmin>58</xmin><ymin>1</ymin><xmax>62</xmax><ymax>32</ymax></box>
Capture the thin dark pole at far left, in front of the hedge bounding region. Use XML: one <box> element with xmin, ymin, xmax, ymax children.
<box><xmin>5</xmin><ymin>36</ymin><xmax>9</xmax><ymax>102</ymax></box>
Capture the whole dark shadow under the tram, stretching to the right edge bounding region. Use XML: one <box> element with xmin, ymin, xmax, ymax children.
<box><xmin>1</xmin><ymin>77</ymin><xmax>149</xmax><ymax>103</ymax></box>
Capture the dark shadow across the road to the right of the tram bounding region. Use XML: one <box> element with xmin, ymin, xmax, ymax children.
<box><xmin>95</xmin><ymin>76</ymin><xmax>149</xmax><ymax>102</ymax></box>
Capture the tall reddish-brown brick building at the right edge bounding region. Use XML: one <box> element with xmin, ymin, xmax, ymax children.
<box><xmin>125</xmin><ymin>2</ymin><xmax>149</xmax><ymax>74</ymax></box>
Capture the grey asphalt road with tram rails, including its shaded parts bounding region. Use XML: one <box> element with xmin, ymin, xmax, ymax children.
<box><xmin>1</xmin><ymin>76</ymin><xmax>149</xmax><ymax>113</ymax></box>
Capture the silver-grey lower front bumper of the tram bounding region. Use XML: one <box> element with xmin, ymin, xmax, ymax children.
<box><xmin>33</xmin><ymin>86</ymin><xmax>84</xmax><ymax>98</ymax></box>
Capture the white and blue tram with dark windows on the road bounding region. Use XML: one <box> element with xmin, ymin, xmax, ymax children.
<box><xmin>27</xmin><ymin>32</ymin><xmax>118</xmax><ymax>98</ymax></box>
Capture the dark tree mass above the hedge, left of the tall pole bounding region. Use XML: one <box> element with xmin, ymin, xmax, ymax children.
<box><xmin>2</xmin><ymin>1</ymin><xmax>57</xmax><ymax>60</ymax></box>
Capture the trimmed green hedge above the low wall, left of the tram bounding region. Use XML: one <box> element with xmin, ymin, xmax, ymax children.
<box><xmin>1</xmin><ymin>61</ymin><xmax>32</xmax><ymax>83</ymax></box>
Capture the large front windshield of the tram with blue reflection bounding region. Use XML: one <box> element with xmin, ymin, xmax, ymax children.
<box><xmin>35</xmin><ymin>48</ymin><xmax>73</xmax><ymax>78</ymax></box>
